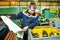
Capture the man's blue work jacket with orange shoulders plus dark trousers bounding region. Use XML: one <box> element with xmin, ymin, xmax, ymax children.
<box><xmin>11</xmin><ymin>10</ymin><xmax>38</xmax><ymax>40</ymax></box>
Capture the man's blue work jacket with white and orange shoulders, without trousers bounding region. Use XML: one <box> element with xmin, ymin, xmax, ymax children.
<box><xmin>11</xmin><ymin>11</ymin><xmax>38</xmax><ymax>28</ymax></box>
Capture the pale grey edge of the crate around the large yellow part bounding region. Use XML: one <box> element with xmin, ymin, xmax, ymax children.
<box><xmin>29</xmin><ymin>30</ymin><xmax>60</xmax><ymax>40</ymax></box>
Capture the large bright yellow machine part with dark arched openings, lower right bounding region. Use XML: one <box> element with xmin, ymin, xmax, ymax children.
<box><xmin>31</xmin><ymin>26</ymin><xmax>60</xmax><ymax>38</ymax></box>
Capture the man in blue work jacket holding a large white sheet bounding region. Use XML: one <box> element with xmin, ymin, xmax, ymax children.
<box><xmin>7</xmin><ymin>2</ymin><xmax>38</xmax><ymax>40</ymax></box>
